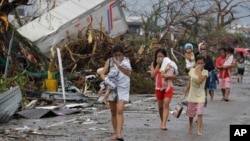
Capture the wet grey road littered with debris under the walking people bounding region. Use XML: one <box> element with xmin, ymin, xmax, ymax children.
<box><xmin>0</xmin><ymin>66</ymin><xmax>250</xmax><ymax>141</ymax></box>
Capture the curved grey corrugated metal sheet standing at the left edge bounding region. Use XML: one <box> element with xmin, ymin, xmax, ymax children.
<box><xmin>0</xmin><ymin>86</ymin><xmax>22</xmax><ymax>122</ymax></box>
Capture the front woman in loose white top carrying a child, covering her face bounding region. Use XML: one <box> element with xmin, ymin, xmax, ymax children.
<box><xmin>101</xmin><ymin>45</ymin><xmax>132</xmax><ymax>141</ymax></box>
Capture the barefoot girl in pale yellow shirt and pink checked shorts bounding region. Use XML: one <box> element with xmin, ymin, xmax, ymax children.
<box><xmin>184</xmin><ymin>56</ymin><xmax>208</xmax><ymax>136</ymax></box>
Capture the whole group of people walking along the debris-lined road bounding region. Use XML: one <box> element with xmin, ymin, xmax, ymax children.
<box><xmin>97</xmin><ymin>42</ymin><xmax>244</xmax><ymax>140</ymax></box>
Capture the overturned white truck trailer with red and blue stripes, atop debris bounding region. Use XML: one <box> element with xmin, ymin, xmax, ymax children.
<box><xmin>18</xmin><ymin>0</ymin><xmax>128</xmax><ymax>54</ymax></box>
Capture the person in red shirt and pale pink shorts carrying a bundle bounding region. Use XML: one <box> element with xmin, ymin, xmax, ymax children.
<box><xmin>216</xmin><ymin>48</ymin><xmax>233</xmax><ymax>102</ymax></box>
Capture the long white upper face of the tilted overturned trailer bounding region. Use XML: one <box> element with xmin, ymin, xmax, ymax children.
<box><xmin>18</xmin><ymin>0</ymin><xmax>105</xmax><ymax>41</ymax></box>
